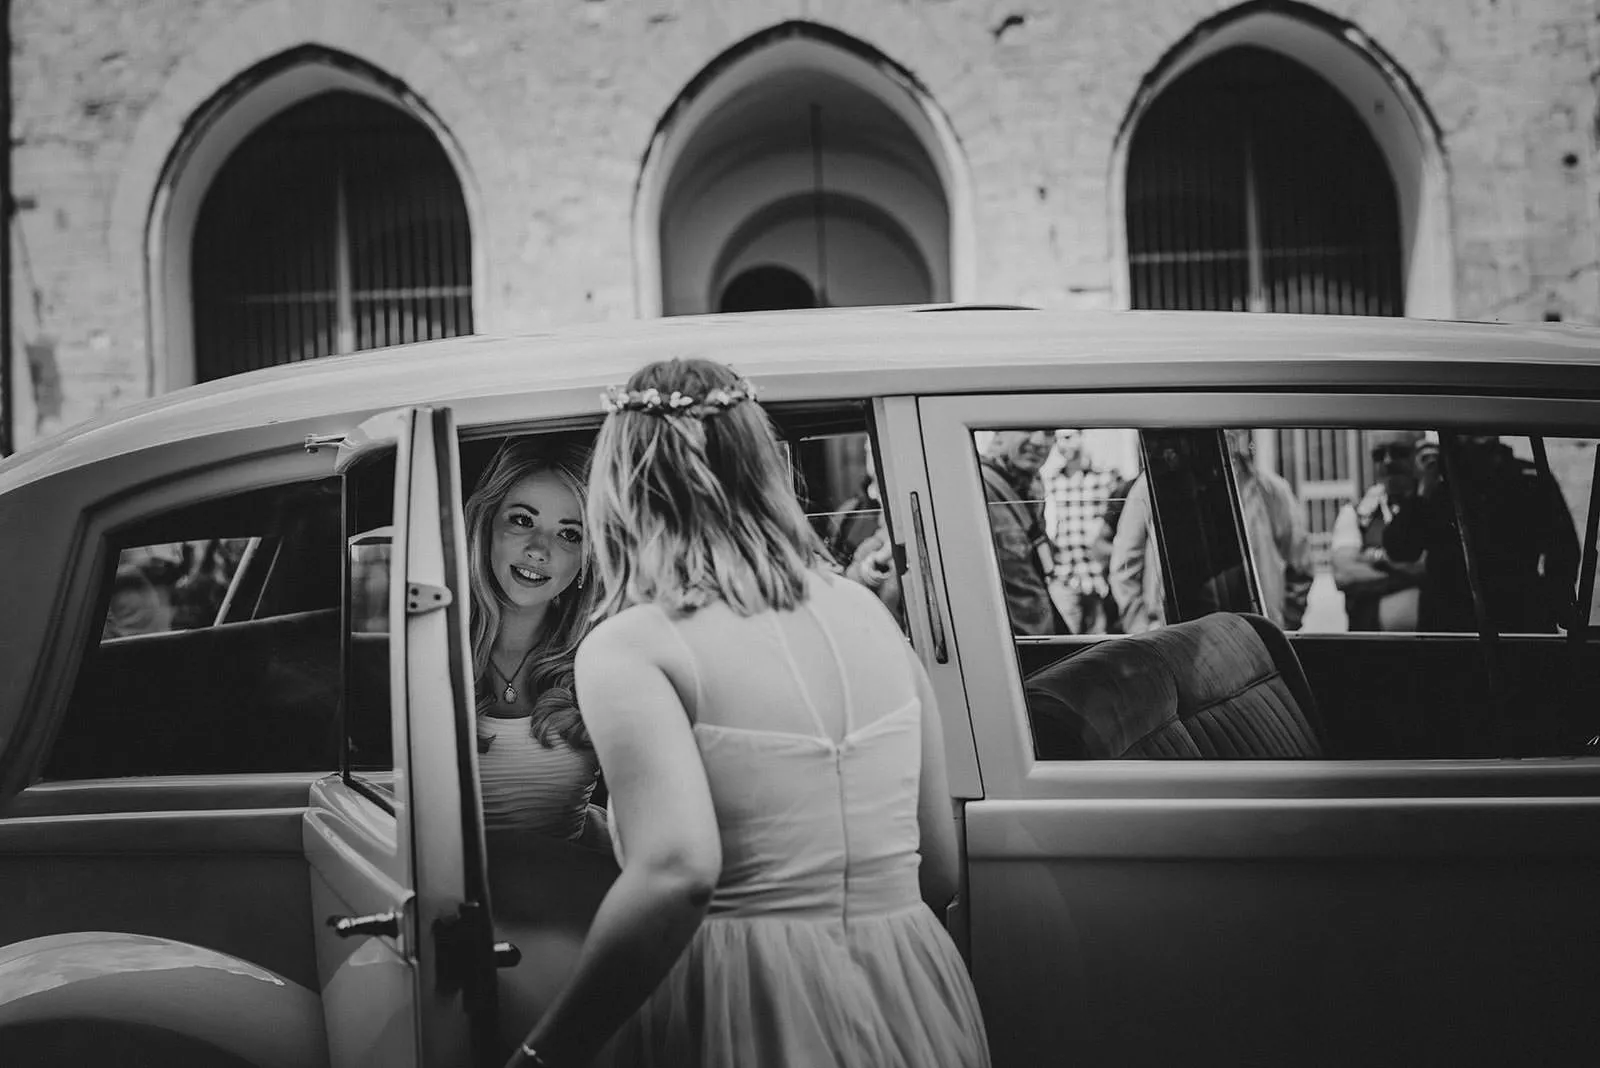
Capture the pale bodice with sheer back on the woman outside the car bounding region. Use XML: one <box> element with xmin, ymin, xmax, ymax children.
<box><xmin>613</xmin><ymin>576</ymin><xmax>922</xmax><ymax>918</ymax></box>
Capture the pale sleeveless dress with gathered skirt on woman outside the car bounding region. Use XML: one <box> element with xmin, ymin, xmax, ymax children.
<box><xmin>595</xmin><ymin>576</ymin><xmax>989</xmax><ymax>1068</ymax></box>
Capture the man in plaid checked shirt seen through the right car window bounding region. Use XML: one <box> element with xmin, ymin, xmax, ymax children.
<box><xmin>1045</xmin><ymin>430</ymin><xmax>1122</xmax><ymax>635</ymax></box>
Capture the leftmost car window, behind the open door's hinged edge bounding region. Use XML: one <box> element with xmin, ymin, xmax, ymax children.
<box><xmin>43</xmin><ymin>480</ymin><xmax>339</xmax><ymax>780</ymax></box>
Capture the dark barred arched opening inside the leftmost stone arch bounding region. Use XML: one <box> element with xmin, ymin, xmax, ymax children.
<box><xmin>192</xmin><ymin>93</ymin><xmax>472</xmax><ymax>381</ymax></box>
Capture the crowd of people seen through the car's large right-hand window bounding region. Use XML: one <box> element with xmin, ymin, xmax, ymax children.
<box><xmin>979</xmin><ymin>428</ymin><xmax>1578</xmax><ymax>636</ymax></box>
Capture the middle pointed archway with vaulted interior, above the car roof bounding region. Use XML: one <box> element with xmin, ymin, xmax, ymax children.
<box><xmin>632</xmin><ymin>22</ymin><xmax>976</xmax><ymax>317</ymax></box>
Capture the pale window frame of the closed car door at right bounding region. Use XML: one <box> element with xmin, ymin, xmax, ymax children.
<box><xmin>918</xmin><ymin>389</ymin><xmax>1600</xmax><ymax>799</ymax></box>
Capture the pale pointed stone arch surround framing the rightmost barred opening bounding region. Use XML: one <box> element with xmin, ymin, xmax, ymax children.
<box><xmin>1109</xmin><ymin>0</ymin><xmax>1454</xmax><ymax>318</ymax></box>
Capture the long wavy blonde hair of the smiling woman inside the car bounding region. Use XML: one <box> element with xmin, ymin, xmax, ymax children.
<box><xmin>464</xmin><ymin>438</ymin><xmax>595</xmax><ymax>748</ymax></box>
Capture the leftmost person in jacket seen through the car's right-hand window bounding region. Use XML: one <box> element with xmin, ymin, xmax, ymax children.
<box><xmin>978</xmin><ymin>430</ymin><xmax>1072</xmax><ymax>635</ymax></box>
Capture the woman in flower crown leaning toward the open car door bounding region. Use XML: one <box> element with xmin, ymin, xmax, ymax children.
<box><xmin>510</xmin><ymin>360</ymin><xmax>989</xmax><ymax>1068</ymax></box>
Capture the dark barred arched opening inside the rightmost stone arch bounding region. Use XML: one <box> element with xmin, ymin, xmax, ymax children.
<box><xmin>1125</xmin><ymin>46</ymin><xmax>1405</xmax><ymax>315</ymax></box>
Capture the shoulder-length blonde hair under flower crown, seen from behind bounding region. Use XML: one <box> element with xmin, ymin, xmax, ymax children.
<box><xmin>586</xmin><ymin>360</ymin><xmax>827</xmax><ymax>616</ymax></box>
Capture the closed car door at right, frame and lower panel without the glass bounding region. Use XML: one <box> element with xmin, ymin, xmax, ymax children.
<box><xmin>920</xmin><ymin>390</ymin><xmax>1600</xmax><ymax>1065</ymax></box>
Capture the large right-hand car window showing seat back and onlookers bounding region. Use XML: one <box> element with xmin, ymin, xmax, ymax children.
<box><xmin>974</xmin><ymin>427</ymin><xmax>1600</xmax><ymax>759</ymax></box>
